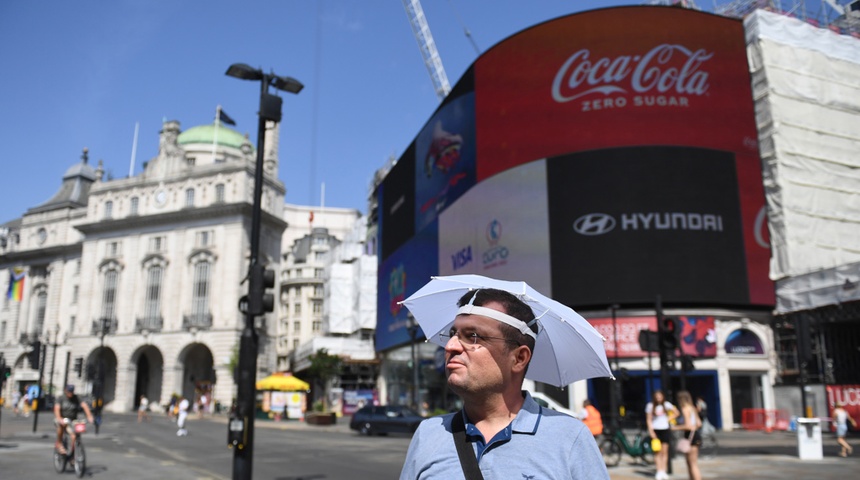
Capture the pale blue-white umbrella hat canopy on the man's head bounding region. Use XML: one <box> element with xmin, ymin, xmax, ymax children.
<box><xmin>402</xmin><ymin>275</ymin><xmax>614</xmax><ymax>387</ymax></box>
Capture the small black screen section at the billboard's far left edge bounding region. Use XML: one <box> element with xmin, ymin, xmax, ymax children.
<box><xmin>379</xmin><ymin>142</ymin><xmax>415</xmax><ymax>261</ymax></box>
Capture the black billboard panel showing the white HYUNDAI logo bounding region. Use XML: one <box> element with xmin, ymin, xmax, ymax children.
<box><xmin>547</xmin><ymin>146</ymin><xmax>749</xmax><ymax>307</ymax></box>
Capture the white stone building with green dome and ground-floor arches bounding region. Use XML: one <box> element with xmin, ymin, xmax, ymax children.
<box><xmin>0</xmin><ymin>117</ymin><xmax>287</xmax><ymax>411</ymax></box>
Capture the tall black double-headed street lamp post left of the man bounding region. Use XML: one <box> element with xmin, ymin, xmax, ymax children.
<box><xmin>226</xmin><ymin>63</ymin><xmax>304</xmax><ymax>480</ymax></box>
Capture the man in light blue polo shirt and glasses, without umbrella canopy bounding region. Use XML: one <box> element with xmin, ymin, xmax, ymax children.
<box><xmin>400</xmin><ymin>289</ymin><xmax>609</xmax><ymax>480</ymax></box>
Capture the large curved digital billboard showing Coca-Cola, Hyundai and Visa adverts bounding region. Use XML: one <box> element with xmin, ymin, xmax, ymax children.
<box><xmin>380</xmin><ymin>6</ymin><xmax>774</xmax><ymax>352</ymax></box>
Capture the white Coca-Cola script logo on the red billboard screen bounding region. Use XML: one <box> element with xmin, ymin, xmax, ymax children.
<box><xmin>552</xmin><ymin>44</ymin><xmax>714</xmax><ymax>103</ymax></box>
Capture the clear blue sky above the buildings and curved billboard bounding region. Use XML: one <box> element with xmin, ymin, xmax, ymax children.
<box><xmin>0</xmin><ymin>0</ymin><xmax>840</xmax><ymax>223</ymax></box>
